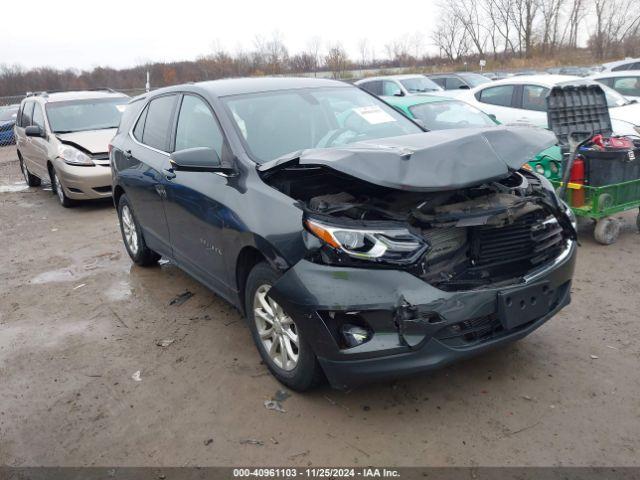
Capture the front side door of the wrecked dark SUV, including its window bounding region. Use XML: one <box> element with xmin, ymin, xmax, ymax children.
<box><xmin>165</xmin><ymin>93</ymin><xmax>230</xmax><ymax>291</ymax></box>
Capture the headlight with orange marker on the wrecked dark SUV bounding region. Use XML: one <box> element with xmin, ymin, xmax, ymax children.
<box><xmin>305</xmin><ymin>219</ymin><xmax>429</xmax><ymax>264</ymax></box>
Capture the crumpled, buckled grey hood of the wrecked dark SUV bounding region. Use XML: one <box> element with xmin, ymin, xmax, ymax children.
<box><xmin>258</xmin><ymin>127</ymin><xmax>557</xmax><ymax>191</ymax></box>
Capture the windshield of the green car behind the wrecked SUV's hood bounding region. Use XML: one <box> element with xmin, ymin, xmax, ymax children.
<box><xmin>409</xmin><ymin>100</ymin><xmax>496</xmax><ymax>130</ymax></box>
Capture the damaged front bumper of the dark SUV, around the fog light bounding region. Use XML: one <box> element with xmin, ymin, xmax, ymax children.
<box><xmin>269</xmin><ymin>241</ymin><xmax>576</xmax><ymax>388</ymax></box>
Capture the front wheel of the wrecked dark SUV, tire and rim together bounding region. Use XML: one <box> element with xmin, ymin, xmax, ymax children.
<box><xmin>245</xmin><ymin>262</ymin><xmax>323</xmax><ymax>391</ymax></box>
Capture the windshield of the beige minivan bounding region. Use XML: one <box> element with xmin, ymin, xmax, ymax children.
<box><xmin>47</xmin><ymin>97</ymin><xmax>129</xmax><ymax>133</ymax></box>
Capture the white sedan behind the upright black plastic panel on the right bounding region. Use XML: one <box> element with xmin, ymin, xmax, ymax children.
<box><xmin>456</xmin><ymin>75</ymin><xmax>640</xmax><ymax>135</ymax></box>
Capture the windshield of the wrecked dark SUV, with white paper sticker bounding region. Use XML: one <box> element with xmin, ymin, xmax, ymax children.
<box><xmin>223</xmin><ymin>87</ymin><xmax>422</xmax><ymax>163</ymax></box>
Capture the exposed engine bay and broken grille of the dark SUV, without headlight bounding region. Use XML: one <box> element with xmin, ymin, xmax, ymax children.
<box><xmin>263</xmin><ymin>166</ymin><xmax>575</xmax><ymax>290</ymax></box>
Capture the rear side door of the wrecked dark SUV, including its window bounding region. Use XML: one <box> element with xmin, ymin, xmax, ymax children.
<box><xmin>119</xmin><ymin>93</ymin><xmax>178</xmax><ymax>256</ymax></box>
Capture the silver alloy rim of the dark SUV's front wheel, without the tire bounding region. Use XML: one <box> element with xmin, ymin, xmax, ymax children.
<box><xmin>253</xmin><ymin>285</ymin><xmax>300</xmax><ymax>371</ymax></box>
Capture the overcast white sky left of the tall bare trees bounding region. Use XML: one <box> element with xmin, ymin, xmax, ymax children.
<box><xmin>0</xmin><ymin>0</ymin><xmax>437</xmax><ymax>69</ymax></box>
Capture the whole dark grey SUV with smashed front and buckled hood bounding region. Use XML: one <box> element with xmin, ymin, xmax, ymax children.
<box><xmin>110</xmin><ymin>78</ymin><xmax>576</xmax><ymax>390</ymax></box>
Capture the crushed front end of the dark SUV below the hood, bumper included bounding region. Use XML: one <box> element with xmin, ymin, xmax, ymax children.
<box><xmin>267</xmin><ymin>129</ymin><xmax>576</xmax><ymax>388</ymax></box>
